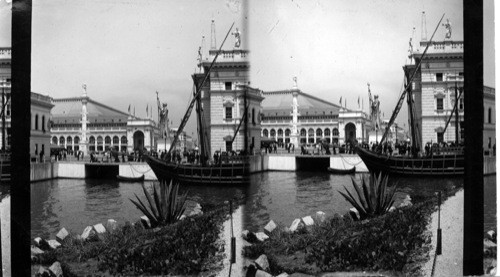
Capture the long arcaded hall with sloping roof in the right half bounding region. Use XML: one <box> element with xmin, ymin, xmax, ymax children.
<box><xmin>261</xmin><ymin>82</ymin><xmax>371</xmax><ymax>147</ymax></box>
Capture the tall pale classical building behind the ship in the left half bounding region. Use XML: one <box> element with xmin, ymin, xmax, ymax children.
<box><xmin>193</xmin><ymin>44</ymin><xmax>263</xmax><ymax>155</ymax></box>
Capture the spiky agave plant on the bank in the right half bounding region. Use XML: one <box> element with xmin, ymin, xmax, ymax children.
<box><xmin>339</xmin><ymin>170</ymin><xmax>396</xmax><ymax>220</ymax></box>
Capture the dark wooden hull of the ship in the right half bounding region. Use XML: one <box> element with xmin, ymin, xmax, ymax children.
<box><xmin>356</xmin><ymin>147</ymin><xmax>464</xmax><ymax>177</ymax></box>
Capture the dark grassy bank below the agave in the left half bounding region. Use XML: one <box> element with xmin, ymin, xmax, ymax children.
<box><xmin>33</xmin><ymin>202</ymin><xmax>229</xmax><ymax>276</ymax></box>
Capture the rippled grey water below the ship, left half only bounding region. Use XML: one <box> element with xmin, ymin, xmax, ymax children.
<box><xmin>31</xmin><ymin>179</ymin><xmax>243</xmax><ymax>238</ymax></box>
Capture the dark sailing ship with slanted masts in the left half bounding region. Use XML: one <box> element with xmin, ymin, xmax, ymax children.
<box><xmin>145</xmin><ymin>23</ymin><xmax>250</xmax><ymax>185</ymax></box>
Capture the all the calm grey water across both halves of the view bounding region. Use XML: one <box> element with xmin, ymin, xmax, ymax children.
<box><xmin>31</xmin><ymin>172</ymin><xmax>496</xmax><ymax>237</ymax></box>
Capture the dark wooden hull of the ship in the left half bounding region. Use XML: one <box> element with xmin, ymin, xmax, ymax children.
<box><xmin>146</xmin><ymin>156</ymin><xmax>250</xmax><ymax>185</ymax></box>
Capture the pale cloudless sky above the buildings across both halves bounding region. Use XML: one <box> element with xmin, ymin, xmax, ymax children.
<box><xmin>0</xmin><ymin>0</ymin><xmax>495</xmax><ymax>135</ymax></box>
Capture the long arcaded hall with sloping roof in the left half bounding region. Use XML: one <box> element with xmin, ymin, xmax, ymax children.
<box><xmin>51</xmin><ymin>86</ymin><xmax>159</xmax><ymax>154</ymax></box>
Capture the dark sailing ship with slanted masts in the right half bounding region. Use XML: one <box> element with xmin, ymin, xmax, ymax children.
<box><xmin>356</xmin><ymin>15</ymin><xmax>464</xmax><ymax>177</ymax></box>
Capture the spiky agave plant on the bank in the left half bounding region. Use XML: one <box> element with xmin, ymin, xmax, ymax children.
<box><xmin>130</xmin><ymin>181</ymin><xmax>187</xmax><ymax>228</ymax></box>
